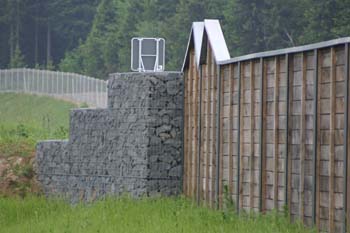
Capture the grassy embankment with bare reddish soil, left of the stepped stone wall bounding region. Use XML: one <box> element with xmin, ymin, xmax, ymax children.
<box><xmin>0</xmin><ymin>93</ymin><xmax>76</xmax><ymax>196</ymax></box>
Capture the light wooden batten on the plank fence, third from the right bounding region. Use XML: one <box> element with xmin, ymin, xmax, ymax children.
<box><xmin>273</xmin><ymin>56</ymin><xmax>280</xmax><ymax>210</ymax></box>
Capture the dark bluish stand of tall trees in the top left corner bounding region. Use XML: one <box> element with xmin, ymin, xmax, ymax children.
<box><xmin>0</xmin><ymin>0</ymin><xmax>99</xmax><ymax>67</ymax></box>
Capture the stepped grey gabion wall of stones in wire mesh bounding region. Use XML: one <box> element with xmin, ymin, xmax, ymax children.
<box><xmin>36</xmin><ymin>72</ymin><xmax>183</xmax><ymax>202</ymax></box>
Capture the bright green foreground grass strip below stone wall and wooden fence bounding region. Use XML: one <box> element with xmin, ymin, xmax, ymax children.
<box><xmin>0</xmin><ymin>197</ymin><xmax>314</xmax><ymax>233</ymax></box>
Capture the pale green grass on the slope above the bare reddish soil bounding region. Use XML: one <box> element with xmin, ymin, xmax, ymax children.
<box><xmin>0</xmin><ymin>93</ymin><xmax>76</xmax><ymax>157</ymax></box>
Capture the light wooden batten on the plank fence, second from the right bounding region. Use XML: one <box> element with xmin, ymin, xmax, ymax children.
<box><xmin>299</xmin><ymin>53</ymin><xmax>307</xmax><ymax>222</ymax></box>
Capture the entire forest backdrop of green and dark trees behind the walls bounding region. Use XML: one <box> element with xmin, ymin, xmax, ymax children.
<box><xmin>0</xmin><ymin>0</ymin><xmax>350</xmax><ymax>79</ymax></box>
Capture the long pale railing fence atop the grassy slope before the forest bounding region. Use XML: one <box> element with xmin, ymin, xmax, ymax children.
<box><xmin>0</xmin><ymin>68</ymin><xmax>107</xmax><ymax>108</ymax></box>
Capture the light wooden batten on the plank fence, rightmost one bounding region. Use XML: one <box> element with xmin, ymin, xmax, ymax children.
<box><xmin>328</xmin><ymin>47</ymin><xmax>336</xmax><ymax>232</ymax></box>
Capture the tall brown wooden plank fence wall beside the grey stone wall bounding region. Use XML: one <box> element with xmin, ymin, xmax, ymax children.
<box><xmin>183</xmin><ymin>39</ymin><xmax>350</xmax><ymax>232</ymax></box>
